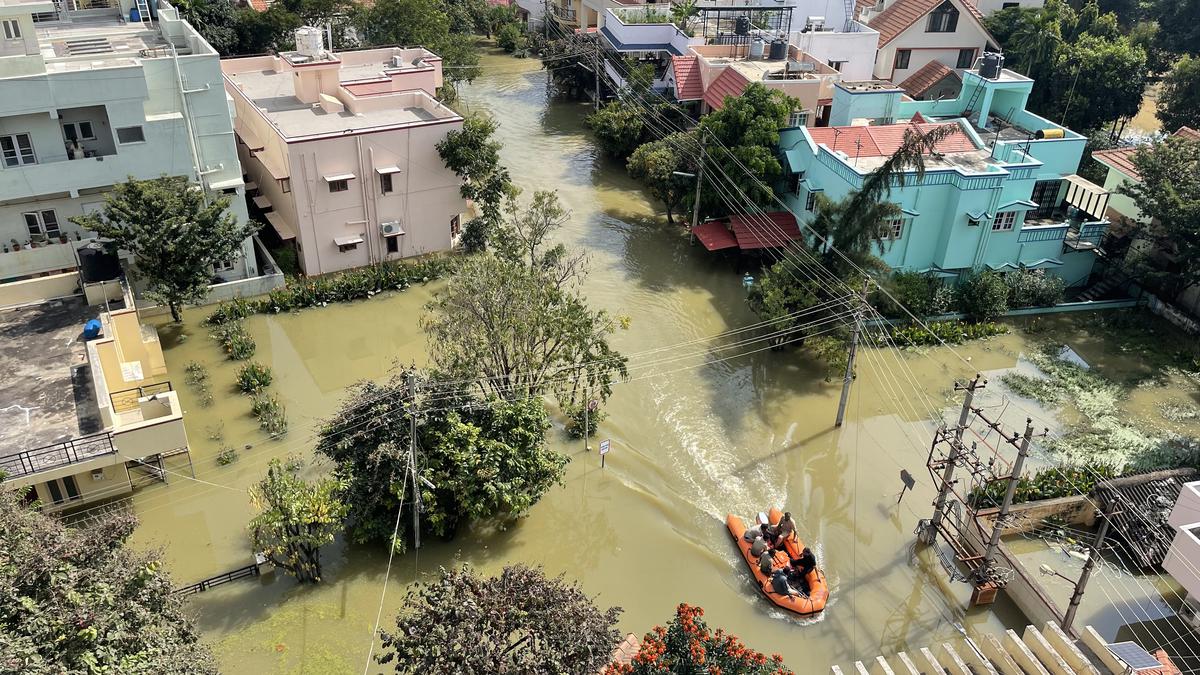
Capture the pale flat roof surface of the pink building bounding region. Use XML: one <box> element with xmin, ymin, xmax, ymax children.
<box><xmin>226</xmin><ymin>64</ymin><xmax>439</xmax><ymax>137</ymax></box>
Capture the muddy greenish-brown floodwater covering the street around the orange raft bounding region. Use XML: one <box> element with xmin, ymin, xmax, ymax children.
<box><xmin>108</xmin><ymin>49</ymin><xmax>1195</xmax><ymax>673</ymax></box>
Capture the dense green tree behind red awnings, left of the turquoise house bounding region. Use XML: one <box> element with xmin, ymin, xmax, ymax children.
<box><xmin>700</xmin><ymin>82</ymin><xmax>802</xmax><ymax>209</ymax></box>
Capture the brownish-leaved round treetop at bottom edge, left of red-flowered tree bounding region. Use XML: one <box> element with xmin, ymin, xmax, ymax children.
<box><xmin>378</xmin><ymin>565</ymin><xmax>620</xmax><ymax>675</ymax></box>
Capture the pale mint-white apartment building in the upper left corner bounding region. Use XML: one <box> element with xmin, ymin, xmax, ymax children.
<box><xmin>0</xmin><ymin>0</ymin><xmax>258</xmax><ymax>296</ymax></box>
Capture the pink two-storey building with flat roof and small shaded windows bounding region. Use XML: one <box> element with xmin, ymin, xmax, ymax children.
<box><xmin>221</xmin><ymin>28</ymin><xmax>467</xmax><ymax>275</ymax></box>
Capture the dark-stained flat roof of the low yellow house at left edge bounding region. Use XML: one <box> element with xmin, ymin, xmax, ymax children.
<box><xmin>0</xmin><ymin>299</ymin><xmax>102</xmax><ymax>456</ymax></box>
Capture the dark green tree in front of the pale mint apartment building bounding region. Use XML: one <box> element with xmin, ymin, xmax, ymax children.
<box><xmin>71</xmin><ymin>177</ymin><xmax>258</xmax><ymax>322</ymax></box>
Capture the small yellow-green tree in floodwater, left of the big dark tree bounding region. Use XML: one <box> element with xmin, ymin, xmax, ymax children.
<box><xmin>248</xmin><ymin>459</ymin><xmax>347</xmax><ymax>584</ymax></box>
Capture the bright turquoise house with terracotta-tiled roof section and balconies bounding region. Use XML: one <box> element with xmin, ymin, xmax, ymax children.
<box><xmin>780</xmin><ymin>71</ymin><xmax>1108</xmax><ymax>286</ymax></box>
